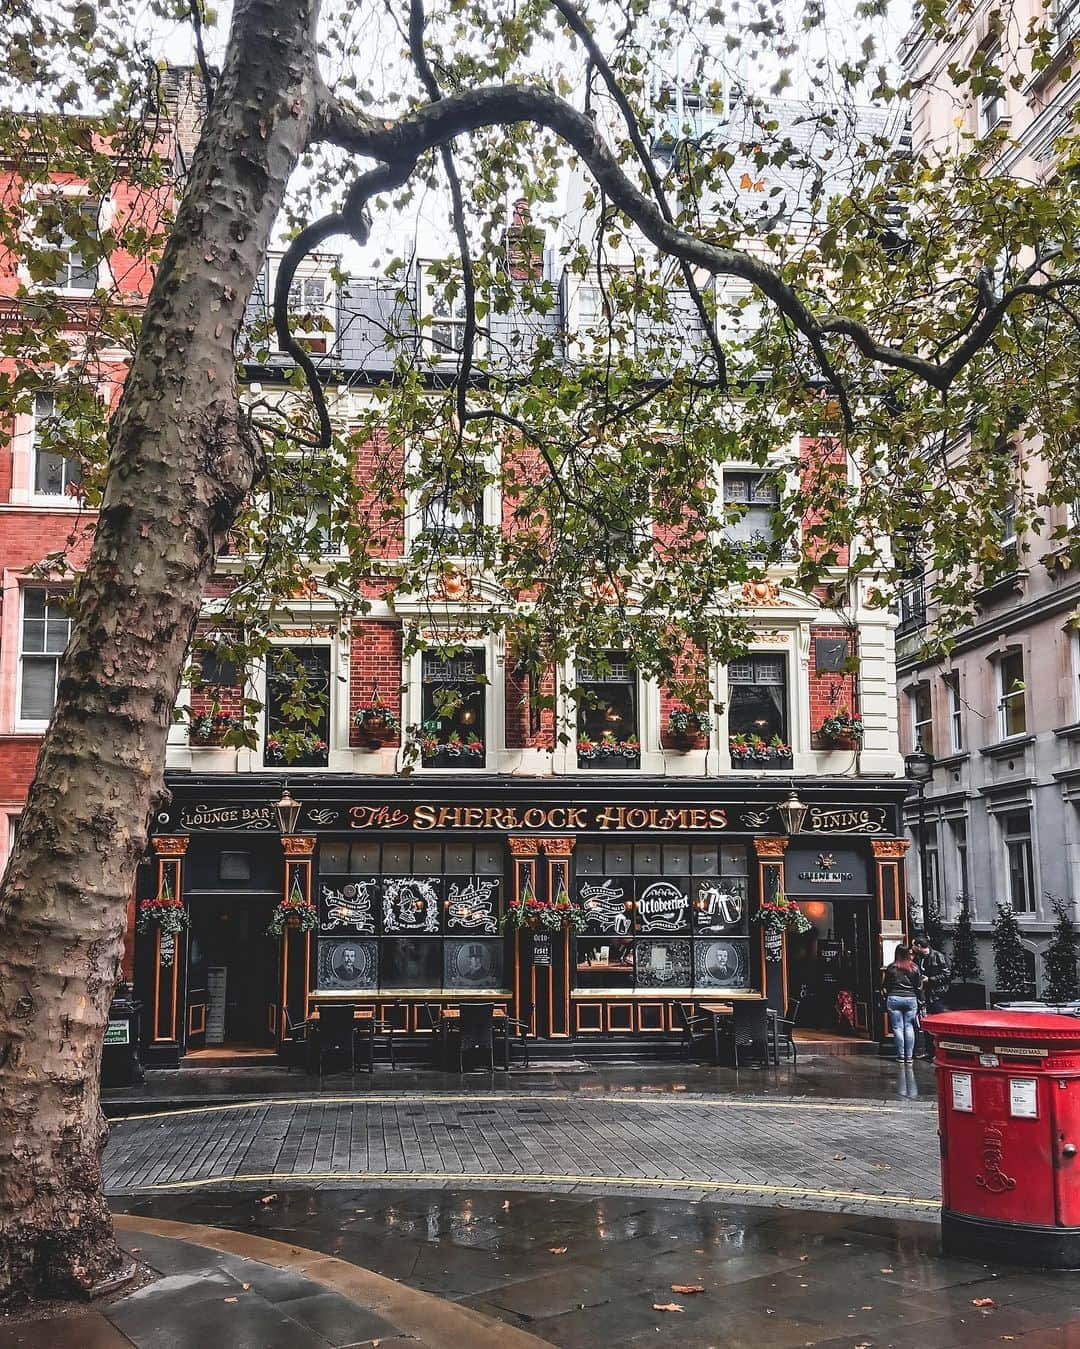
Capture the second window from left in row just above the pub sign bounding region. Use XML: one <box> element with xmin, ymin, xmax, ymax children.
<box><xmin>421</xmin><ymin>649</ymin><xmax>488</xmax><ymax>770</ymax></box>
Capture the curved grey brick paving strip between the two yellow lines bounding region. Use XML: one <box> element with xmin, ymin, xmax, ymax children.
<box><xmin>105</xmin><ymin>1090</ymin><xmax>938</xmax><ymax>1218</ymax></box>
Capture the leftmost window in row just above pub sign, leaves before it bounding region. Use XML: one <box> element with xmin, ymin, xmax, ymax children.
<box><xmin>263</xmin><ymin>646</ymin><xmax>330</xmax><ymax>768</ymax></box>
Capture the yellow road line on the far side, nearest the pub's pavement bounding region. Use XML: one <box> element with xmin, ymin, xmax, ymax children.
<box><xmin>111</xmin><ymin>1091</ymin><xmax>899</xmax><ymax>1124</ymax></box>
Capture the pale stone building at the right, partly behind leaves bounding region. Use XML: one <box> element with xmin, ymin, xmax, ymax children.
<box><xmin>898</xmin><ymin>0</ymin><xmax>1080</xmax><ymax>989</ymax></box>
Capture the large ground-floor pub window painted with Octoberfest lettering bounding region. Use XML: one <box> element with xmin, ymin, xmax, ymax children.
<box><xmin>574</xmin><ymin>842</ymin><xmax>750</xmax><ymax>992</ymax></box>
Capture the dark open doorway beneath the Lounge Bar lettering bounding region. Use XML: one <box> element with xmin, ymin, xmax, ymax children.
<box><xmin>187</xmin><ymin>894</ymin><xmax>280</xmax><ymax>1050</ymax></box>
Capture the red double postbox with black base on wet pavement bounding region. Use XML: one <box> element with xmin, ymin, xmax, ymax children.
<box><xmin>924</xmin><ymin>1010</ymin><xmax>1080</xmax><ymax>1269</ymax></box>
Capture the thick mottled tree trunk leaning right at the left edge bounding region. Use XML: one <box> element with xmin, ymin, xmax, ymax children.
<box><xmin>0</xmin><ymin>0</ymin><xmax>318</xmax><ymax>1300</ymax></box>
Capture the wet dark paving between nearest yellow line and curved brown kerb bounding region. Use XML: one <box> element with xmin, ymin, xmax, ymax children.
<box><xmin>115</xmin><ymin>1187</ymin><xmax>1080</xmax><ymax>1349</ymax></box>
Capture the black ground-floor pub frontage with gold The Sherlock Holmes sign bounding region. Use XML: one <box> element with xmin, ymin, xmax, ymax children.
<box><xmin>135</xmin><ymin>772</ymin><xmax>907</xmax><ymax>1067</ymax></box>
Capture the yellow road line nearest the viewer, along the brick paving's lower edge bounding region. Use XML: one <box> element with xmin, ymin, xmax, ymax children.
<box><xmin>139</xmin><ymin>1171</ymin><xmax>941</xmax><ymax>1210</ymax></box>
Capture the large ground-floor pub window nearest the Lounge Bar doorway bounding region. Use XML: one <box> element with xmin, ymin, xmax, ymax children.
<box><xmin>317</xmin><ymin>839</ymin><xmax>504</xmax><ymax>994</ymax></box>
